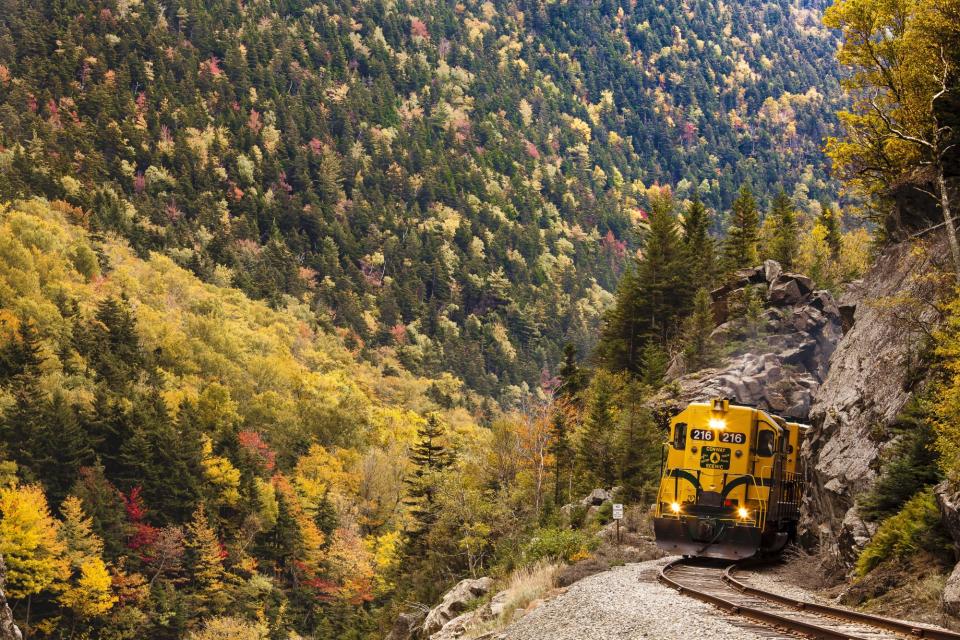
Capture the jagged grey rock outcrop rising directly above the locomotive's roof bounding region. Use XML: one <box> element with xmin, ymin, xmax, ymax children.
<box><xmin>654</xmin><ymin>260</ymin><xmax>842</xmax><ymax>421</ymax></box>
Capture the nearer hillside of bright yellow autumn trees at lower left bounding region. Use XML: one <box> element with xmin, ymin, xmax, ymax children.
<box><xmin>0</xmin><ymin>200</ymin><xmax>489</xmax><ymax>638</ymax></box>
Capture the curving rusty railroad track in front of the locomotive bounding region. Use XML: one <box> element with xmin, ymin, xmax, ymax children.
<box><xmin>658</xmin><ymin>559</ymin><xmax>960</xmax><ymax>640</ymax></box>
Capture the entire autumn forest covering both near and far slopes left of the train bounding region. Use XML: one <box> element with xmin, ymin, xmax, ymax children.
<box><xmin>0</xmin><ymin>0</ymin><xmax>900</xmax><ymax>640</ymax></box>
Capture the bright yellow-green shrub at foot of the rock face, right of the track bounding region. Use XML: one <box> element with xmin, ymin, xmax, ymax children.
<box><xmin>856</xmin><ymin>488</ymin><xmax>952</xmax><ymax>576</ymax></box>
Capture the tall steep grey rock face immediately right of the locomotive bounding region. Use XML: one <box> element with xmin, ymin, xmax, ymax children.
<box><xmin>800</xmin><ymin>235</ymin><xmax>946</xmax><ymax>562</ymax></box>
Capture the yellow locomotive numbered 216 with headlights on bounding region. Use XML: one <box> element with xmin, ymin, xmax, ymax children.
<box><xmin>653</xmin><ymin>398</ymin><xmax>808</xmax><ymax>560</ymax></box>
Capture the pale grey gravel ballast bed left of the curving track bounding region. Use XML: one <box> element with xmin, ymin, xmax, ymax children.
<box><xmin>501</xmin><ymin>558</ymin><xmax>770</xmax><ymax>640</ymax></box>
